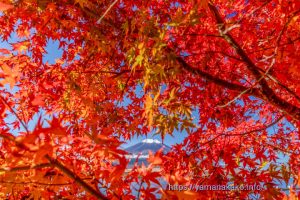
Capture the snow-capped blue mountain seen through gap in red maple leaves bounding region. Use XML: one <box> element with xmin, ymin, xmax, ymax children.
<box><xmin>125</xmin><ymin>139</ymin><xmax>171</xmax><ymax>167</ymax></box>
